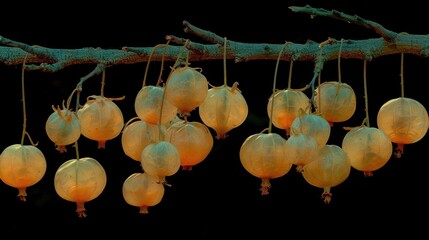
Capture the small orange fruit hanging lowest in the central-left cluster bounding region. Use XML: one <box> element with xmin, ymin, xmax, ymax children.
<box><xmin>122</xmin><ymin>173</ymin><xmax>165</xmax><ymax>214</ymax></box>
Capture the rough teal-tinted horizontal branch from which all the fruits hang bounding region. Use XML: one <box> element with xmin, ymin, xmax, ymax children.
<box><xmin>0</xmin><ymin>5</ymin><xmax>429</xmax><ymax>74</ymax></box>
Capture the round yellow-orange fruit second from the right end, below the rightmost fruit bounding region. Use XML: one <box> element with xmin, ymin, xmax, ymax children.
<box><xmin>342</xmin><ymin>126</ymin><xmax>392</xmax><ymax>176</ymax></box>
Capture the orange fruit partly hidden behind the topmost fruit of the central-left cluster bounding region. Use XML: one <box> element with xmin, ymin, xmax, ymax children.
<box><xmin>134</xmin><ymin>86</ymin><xmax>177</xmax><ymax>125</ymax></box>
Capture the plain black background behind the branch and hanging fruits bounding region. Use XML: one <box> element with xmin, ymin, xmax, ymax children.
<box><xmin>0</xmin><ymin>1</ymin><xmax>429</xmax><ymax>239</ymax></box>
